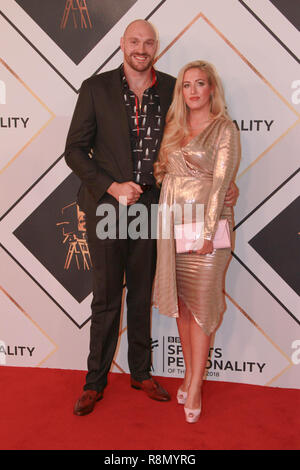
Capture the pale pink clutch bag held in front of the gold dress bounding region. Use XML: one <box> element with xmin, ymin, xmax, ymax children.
<box><xmin>174</xmin><ymin>219</ymin><xmax>231</xmax><ymax>253</ymax></box>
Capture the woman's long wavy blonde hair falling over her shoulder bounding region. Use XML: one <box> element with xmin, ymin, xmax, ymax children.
<box><xmin>154</xmin><ymin>60</ymin><xmax>227</xmax><ymax>184</ymax></box>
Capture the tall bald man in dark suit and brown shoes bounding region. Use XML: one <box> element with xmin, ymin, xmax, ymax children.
<box><xmin>65</xmin><ymin>20</ymin><xmax>175</xmax><ymax>415</ymax></box>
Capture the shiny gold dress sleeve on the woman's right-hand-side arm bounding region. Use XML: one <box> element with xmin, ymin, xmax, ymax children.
<box><xmin>204</xmin><ymin>120</ymin><xmax>240</xmax><ymax>240</ymax></box>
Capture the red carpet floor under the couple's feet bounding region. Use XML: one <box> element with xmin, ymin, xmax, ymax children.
<box><xmin>0</xmin><ymin>366</ymin><xmax>300</xmax><ymax>450</ymax></box>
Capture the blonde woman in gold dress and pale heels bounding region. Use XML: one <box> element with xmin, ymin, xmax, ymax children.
<box><xmin>155</xmin><ymin>61</ymin><xmax>240</xmax><ymax>423</ymax></box>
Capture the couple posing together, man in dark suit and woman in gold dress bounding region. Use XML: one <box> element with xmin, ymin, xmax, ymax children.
<box><xmin>65</xmin><ymin>20</ymin><xmax>239</xmax><ymax>422</ymax></box>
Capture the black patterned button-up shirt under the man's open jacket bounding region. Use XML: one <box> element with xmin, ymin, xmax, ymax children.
<box><xmin>120</xmin><ymin>65</ymin><xmax>162</xmax><ymax>185</ymax></box>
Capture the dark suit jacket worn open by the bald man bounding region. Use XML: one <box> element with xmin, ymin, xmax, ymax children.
<box><xmin>65</xmin><ymin>69</ymin><xmax>175</xmax><ymax>215</ymax></box>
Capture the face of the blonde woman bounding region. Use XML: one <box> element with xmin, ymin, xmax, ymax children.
<box><xmin>182</xmin><ymin>68</ymin><xmax>213</xmax><ymax>110</ymax></box>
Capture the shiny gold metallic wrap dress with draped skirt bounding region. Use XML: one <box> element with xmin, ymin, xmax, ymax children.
<box><xmin>154</xmin><ymin>117</ymin><xmax>240</xmax><ymax>335</ymax></box>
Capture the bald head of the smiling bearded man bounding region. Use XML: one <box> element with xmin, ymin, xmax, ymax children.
<box><xmin>121</xmin><ymin>21</ymin><xmax>157</xmax><ymax>72</ymax></box>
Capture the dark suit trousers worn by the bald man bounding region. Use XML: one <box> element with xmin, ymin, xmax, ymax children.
<box><xmin>84</xmin><ymin>190</ymin><xmax>158</xmax><ymax>391</ymax></box>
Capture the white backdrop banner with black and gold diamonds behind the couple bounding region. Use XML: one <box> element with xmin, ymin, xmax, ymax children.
<box><xmin>0</xmin><ymin>0</ymin><xmax>300</xmax><ymax>388</ymax></box>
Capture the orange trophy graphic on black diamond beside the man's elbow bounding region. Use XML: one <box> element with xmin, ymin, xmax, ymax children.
<box><xmin>56</xmin><ymin>202</ymin><xmax>92</xmax><ymax>271</ymax></box>
